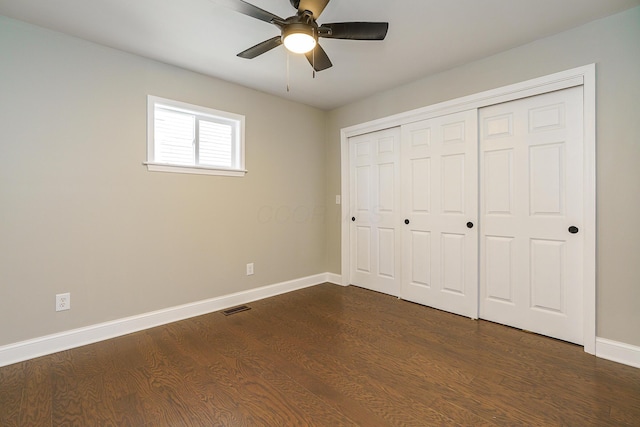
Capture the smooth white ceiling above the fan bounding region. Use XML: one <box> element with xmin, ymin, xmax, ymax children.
<box><xmin>0</xmin><ymin>0</ymin><xmax>640</xmax><ymax>109</ymax></box>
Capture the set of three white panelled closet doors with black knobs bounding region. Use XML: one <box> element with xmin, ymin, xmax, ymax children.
<box><xmin>348</xmin><ymin>85</ymin><xmax>584</xmax><ymax>344</ymax></box>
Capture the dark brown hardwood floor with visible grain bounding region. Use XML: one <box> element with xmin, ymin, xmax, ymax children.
<box><xmin>0</xmin><ymin>284</ymin><xmax>640</xmax><ymax>427</ymax></box>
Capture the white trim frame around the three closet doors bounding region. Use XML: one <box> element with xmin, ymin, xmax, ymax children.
<box><xmin>340</xmin><ymin>64</ymin><xmax>596</xmax><ymax>354</ymax></box>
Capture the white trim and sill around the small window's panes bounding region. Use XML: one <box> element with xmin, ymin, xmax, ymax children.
<box><xmin>143</xmin><ymin>95</ymin><xmax>247</xmax><ymax>176</ymax></box>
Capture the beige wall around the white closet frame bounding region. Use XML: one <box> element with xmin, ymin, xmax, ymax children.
<box><xmin>327</xmin><ymin>8</ymin><xmax>640</xmax><ymax>345</ymax></box>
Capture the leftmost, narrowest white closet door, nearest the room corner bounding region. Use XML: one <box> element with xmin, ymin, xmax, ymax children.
<box><xmin>349</xmin><ymin>128</ymin><xmax>401</xmax><ymax>296</ymax></box>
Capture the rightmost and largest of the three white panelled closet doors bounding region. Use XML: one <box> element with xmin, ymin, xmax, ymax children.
<box><xmin>479</xmin><ymin>87</ymin><xmax>583</xmax><ymax>344</ymax></box>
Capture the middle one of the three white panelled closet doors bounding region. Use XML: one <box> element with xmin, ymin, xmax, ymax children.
<box><xmin>401</xmin><ymin>110</ymin><xmax>478</xmax><ymax>318</ymax></box>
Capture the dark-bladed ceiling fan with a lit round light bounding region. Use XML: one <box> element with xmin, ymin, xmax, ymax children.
<box><xmin>215</xmin><ymin>0</ymin><xmax>389</xmax><ymax>71</ymax></box>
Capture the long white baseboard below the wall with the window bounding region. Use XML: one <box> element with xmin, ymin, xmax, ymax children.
<box><xmin>0</xmin><ymin>273</ymin><xmax>340</xmax><ymax>366</ymax></box>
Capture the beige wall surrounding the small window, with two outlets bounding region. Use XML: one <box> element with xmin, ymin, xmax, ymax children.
<box><xmin>0</xmin><ymin>17</ymin><xmax>326</xmax><ymax>345</ymax></box>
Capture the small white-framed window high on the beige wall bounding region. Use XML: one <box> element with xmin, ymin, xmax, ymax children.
<box><xmin>145</xmin><ymin>96</ymin><xmax>246</xmax><ymax>176</ymax></box>
